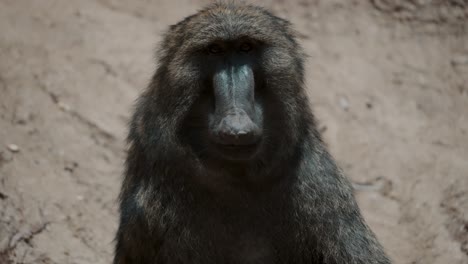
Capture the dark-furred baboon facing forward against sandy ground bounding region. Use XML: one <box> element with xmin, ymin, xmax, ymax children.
<box><xmin>114</xmin><ymin>2</ymin><xmax>390</xmax><ymax>264</ymax></box>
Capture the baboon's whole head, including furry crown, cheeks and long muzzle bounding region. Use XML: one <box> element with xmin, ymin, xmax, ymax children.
<box><xmin>163</xmin><ymin>5</ymin><xmax>302</xmax><ymax>161</ymax></box>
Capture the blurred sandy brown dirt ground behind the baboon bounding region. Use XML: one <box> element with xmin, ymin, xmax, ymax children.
<box><xmin>0</xmin><ymin>0</ymin><xmax>468</xmax><ymax>264</ymax></box>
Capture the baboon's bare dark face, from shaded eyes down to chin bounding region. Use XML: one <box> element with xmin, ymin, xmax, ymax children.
<box><xmin>196</xmin><ymin>38</ymin><xmax>263</xmax><ymax>160</ymax></box>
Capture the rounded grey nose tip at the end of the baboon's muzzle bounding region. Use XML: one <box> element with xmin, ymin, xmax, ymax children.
<box><xmin>215</xmin><ymin>109</ymin><xmax>261</xmax><ymax>146</ymax></box>
